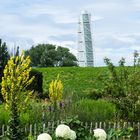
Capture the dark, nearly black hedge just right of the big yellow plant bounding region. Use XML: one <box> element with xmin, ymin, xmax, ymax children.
<box><xmin>28</xmin><ymin>69</ymin><xmax>43</xmax><ymax>97</ymax></box>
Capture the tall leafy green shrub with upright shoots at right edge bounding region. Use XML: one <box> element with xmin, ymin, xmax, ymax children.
<box><xmin>101</xmin><ymin>52</ymin><xmax>140</xmax><ymax>121</ymax></box>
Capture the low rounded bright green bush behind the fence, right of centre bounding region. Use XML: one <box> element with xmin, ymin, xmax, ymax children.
<box><xmin>72</xmin><ymin>99</ymin><xmax>116</xmax><ymax>122</ymax></box>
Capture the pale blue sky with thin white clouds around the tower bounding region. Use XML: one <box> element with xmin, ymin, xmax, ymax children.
<box><xmin>0</xmin><ymin>0</ymin><xmax>140</xmax><ymax>66</ymax></box>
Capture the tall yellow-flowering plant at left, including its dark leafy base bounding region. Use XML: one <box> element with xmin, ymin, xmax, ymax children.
<box><xmin>1</xmin><ymin>53</ymin><xmax>34</xmax><ymax>140</ymax></box>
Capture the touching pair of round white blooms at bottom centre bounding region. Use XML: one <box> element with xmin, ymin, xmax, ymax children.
<box><xmin>55</xmin><ymin>124</ymin><xmax>76</xmax><ymax>140</ymax></box>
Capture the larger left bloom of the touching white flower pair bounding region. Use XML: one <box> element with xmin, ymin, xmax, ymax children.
<box><xmin>55</xmin><ymin>124</ymin><xmax>71</xmax><ymax>139</ymax></box>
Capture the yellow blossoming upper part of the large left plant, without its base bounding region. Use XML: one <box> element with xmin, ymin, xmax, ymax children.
<box><xmin>1</xmin><ymin>52</ymin><xmax>34</xmax><ymax>112</ymax></box>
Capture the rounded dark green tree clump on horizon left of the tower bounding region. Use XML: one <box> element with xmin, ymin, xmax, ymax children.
<box><xmin>25</xmin><ymin>44</ymin><xmax>77</xmax><ymax>67</ymax></box>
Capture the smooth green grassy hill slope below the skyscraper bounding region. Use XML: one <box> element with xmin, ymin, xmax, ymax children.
<box><xmin>37</xmin><ymin>67</ymin><xmax>107</xmax><ymax>95</ymax></box>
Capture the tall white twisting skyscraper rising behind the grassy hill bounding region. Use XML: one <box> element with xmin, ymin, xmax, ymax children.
<box><xmin>78</xmin><ymin>11</ymin><xmax>94</xmax><ymax>67</ymax></box>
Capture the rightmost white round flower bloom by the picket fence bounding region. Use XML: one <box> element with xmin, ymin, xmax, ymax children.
<box><xmin>93</xmin><ymin>128</ymin><xmax>107</xmax><ymax>140</ymax></box>
